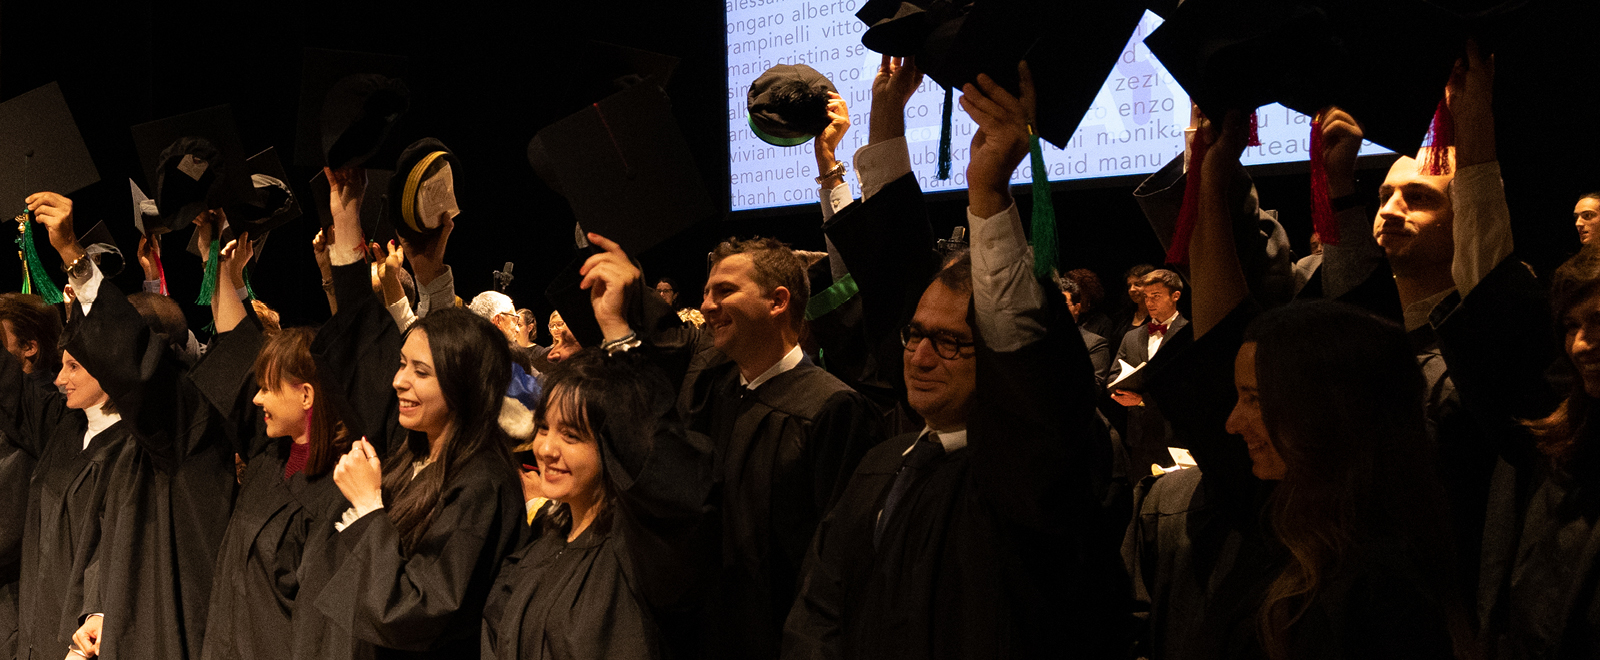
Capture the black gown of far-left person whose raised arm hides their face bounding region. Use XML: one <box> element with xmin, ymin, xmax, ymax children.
<box><xmin>66</xmin><ymin>280</ymin><xmax>244</xmax><ymax>658</ymax></box>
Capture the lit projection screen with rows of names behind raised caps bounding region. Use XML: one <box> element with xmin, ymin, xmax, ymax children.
<box><xmin>725</xmin><ymin>8</ymin><xmax>1387</xmax><ymax>211</ymax></box>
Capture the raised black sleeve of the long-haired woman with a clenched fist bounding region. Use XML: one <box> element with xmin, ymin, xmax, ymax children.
<box><xmin>310</xmin><ymin>263</ymin><xmax>406</xmax><ymax>457</ymax></box>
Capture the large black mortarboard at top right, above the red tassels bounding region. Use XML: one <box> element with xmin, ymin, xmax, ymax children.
<box><xmin>1144</xmin><ymin>0</ymin><xmax>1462</xmax><ymax>154</ymax></box>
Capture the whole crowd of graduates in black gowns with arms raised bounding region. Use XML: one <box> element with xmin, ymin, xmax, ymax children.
<box><xmin>0</xmin><ymin>5</ymin><xmax>1600</xmax><ymax>660</ymax></box>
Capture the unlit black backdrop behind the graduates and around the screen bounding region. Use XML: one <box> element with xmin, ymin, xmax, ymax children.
<box><xmin>0</xmin><ymin>0</ymin><xmax>1600</xmax><ymax>341</ymax></box>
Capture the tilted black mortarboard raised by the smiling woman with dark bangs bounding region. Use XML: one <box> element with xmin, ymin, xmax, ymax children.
<box><xmin>528</xmin><ymin>80</ymin><xmax>714</xmax><ymax>255</ymax></box>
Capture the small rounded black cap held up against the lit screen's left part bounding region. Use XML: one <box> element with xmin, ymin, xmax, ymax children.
<box><xmin>746</xmin><ymin>64</ymin><xmax>838</xmax><ymax>147</ymax></box>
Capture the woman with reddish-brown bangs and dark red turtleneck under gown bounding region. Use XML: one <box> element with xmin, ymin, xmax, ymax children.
<box><xmin>202</xmin><ymin>324</ymin><xmax>350</xmax><ymax>658</ymax></box>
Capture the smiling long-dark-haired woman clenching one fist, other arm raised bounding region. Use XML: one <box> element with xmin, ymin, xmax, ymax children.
<box><xmin>293</xmin><ymin>171</ymin><xmax>531</xmax><ymax>658</ymax></box>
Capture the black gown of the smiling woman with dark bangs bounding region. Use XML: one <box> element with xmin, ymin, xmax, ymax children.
<box><xmin>483</xmin><ymin>360</ymin><xmax>712</xmax><ymax>660</ymax></box>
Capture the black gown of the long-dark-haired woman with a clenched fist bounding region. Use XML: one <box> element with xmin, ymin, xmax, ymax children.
<box><xmin>291</xmin><ymin>264</ymin><xmax>528</xmax><ymax>658</ymax></box>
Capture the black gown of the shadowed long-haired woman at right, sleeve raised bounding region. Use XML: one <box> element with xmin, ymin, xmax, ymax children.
<box><xmin>1123</xmin><ymin>303</ymin><xmax>1453</xmax><ymax>660</ymax></box>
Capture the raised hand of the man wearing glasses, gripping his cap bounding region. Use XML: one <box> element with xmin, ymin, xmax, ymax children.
<box><xmin>962</xmin><ymin>62</ymin><xmax>1034</xmax><ymax>218</ymax></box>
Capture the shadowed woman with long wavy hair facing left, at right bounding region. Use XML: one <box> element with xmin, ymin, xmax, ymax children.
<box><xmin>1227</xmin><ymin>301</ymin><xmax>1466</xmax><ymax>658</ymax></box>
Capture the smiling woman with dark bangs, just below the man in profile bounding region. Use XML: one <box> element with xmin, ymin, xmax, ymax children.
<box><xmin>483</xmin><ymin>348</ymin><xmax>710</xmax><ymax>658</ymax></box>
